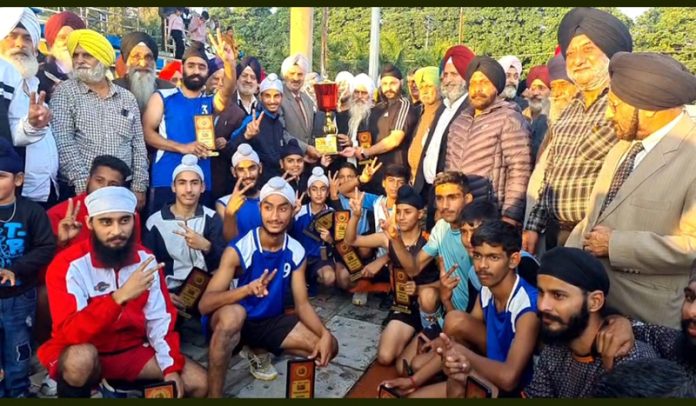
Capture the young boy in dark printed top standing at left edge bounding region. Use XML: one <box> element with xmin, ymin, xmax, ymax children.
<box><xmin>0</xmin><ymin>139</ymin><xmax>56</xmax><ymax>398</ymax></box>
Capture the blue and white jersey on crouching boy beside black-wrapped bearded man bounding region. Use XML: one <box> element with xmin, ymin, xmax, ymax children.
<box><xmin>479</xmin><ymin>275</ymin><xmax>537</xmax><ymax>388</ymax></box>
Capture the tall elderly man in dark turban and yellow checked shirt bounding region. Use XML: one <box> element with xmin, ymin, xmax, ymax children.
<box><xmin>523</xmin><ymin>8</ymin><xmax>633</xmax><ymax>253</ymax></box>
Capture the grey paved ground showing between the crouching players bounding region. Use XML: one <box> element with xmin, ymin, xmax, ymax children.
<box><xmin>32</xmin><ymin>290</ymin><xmax>387</xmax><ymax>398</ymax></box>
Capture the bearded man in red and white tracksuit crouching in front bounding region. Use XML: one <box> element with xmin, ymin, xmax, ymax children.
<box><xmin>38</xmin><ymin>186</ymin><xmax>207</xmax><ymax>397</ymax></box>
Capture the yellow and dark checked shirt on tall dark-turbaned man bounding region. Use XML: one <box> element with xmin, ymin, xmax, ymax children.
<box><xmin>526</xmin><ymin>88</ymin><xmax>618</xmax><ymax>232</ymax></box>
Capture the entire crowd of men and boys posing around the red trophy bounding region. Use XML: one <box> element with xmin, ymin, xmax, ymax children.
<box><xmin>0</xmin><ymin>8</ymin><xmax>696</xmax><ymax>398</ymax></box>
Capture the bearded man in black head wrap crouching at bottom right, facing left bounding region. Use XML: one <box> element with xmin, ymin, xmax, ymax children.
<box><xmin>523</xmin><ymin>247</ymin><xmax>657</xmax><ymax>398</ymax></box>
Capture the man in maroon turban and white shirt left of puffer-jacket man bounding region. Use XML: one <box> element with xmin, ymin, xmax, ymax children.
<box><xmin>413</xmin><ymin>45</ymin><xmax>475</xmax><ymax>229</ymax></box>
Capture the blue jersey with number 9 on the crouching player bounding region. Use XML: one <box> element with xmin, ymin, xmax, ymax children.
<box><xmin>230</xmin><ymin>228</ymin><xmax>305</xmax><ymax>320</ymax></box>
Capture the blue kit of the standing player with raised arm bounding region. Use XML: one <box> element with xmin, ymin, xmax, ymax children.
<box><xmin>151</xmin><ymin>88</ymin><xmax>214</xmax><ymax>190</ymax></box>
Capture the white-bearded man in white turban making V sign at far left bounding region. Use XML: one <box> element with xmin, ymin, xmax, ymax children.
<box><xmin>0</xmin><ymin>7</ymin><xmax>58</xmax><ymax>209</ymax></box>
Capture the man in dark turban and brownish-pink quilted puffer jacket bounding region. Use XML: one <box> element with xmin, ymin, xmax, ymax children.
<box><xmin>445</xmin><ymin>56</ymin><xmax>532</xmax><ymax>224</ymax></box>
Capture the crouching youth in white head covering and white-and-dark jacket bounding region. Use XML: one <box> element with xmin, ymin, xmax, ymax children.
<box><xmin>144</xmin><ymin>154</ymin><xmax>225</xmax><ymax>310</ymax></box>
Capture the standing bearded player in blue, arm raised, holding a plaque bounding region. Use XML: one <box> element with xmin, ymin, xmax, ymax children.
<box><xmin>143</xmin><ymin>36</ymin><xmax>237</xmax><ymax>213</ymax></box>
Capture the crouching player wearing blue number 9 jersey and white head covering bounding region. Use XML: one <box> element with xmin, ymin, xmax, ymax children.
<box><xmin>199</xmin><ymin>177</ymin><xmax>338</xmax><ymax>397</ymax></box>
